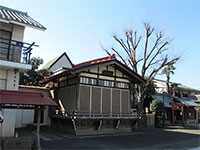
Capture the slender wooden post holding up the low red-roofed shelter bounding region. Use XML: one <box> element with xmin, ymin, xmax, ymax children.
<box><xmin>36</xmin><ymin>106</ymin><xmax>41</xmax><ymax>150</ymax></box>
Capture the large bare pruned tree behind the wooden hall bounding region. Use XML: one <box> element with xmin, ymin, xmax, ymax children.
<box><xmin>103</xmin><ymin>23</ymin><xmax>180</xmax><ymax>112</ymax></box>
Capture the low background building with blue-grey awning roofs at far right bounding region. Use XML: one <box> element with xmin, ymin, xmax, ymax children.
<box><xmin>152</xmin><ymin>79</ymin><xmax>200</xmax><ymax>123</ymax></box>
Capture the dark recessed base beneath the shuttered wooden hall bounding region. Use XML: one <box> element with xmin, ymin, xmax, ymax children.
<box><xmin>52</xmin><ymin>118</ymin><xmax>136</xmax><ymax>135</ymax></box>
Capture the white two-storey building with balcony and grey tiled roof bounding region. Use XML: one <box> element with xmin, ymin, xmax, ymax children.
<box><xmin>0</xmin><ymin>6</ymin><xmax>51</xmax><ymax>137</ymax></box>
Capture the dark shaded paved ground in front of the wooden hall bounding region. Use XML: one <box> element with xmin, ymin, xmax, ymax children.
<box><xmin>38</xmin><ymin>127</ymin><xmax>200</xmax><ymax>150</ymax></box>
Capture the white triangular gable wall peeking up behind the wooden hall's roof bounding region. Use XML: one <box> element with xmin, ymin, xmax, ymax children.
<box><xmin>50</xmin><ymin>55</ymin><xmax>72</xmax><ymax>72</ymax></box>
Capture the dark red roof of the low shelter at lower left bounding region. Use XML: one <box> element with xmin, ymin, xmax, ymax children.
<box><xmin>0</xmin><ymin>90</ymin><xmax>57</xmax><ymax>106</ymax></box>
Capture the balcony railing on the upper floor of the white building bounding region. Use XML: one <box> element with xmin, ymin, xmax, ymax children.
<box><xmin>0</xmin><ymin>38</ymin><xmax>38</xmax><ymax>64</ymax></box>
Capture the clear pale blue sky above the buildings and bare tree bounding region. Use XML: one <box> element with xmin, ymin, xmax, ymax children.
<box><xmin>0</xmin><ymin>0</ymin><xmax>200</xmax><ymax>89</ymax></box>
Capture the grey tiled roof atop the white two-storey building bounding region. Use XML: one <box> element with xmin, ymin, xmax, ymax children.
<box><xmin>0</xmin><ymin>5</ymin><xmax>46</xmax><ymax>30</ymax></box>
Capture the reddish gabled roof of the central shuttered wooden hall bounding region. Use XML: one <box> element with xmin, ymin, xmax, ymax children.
<box><xmin>41</xmin><ymin>54</ymin><xmax>146</xmax><ymax>83</ymax></box>
